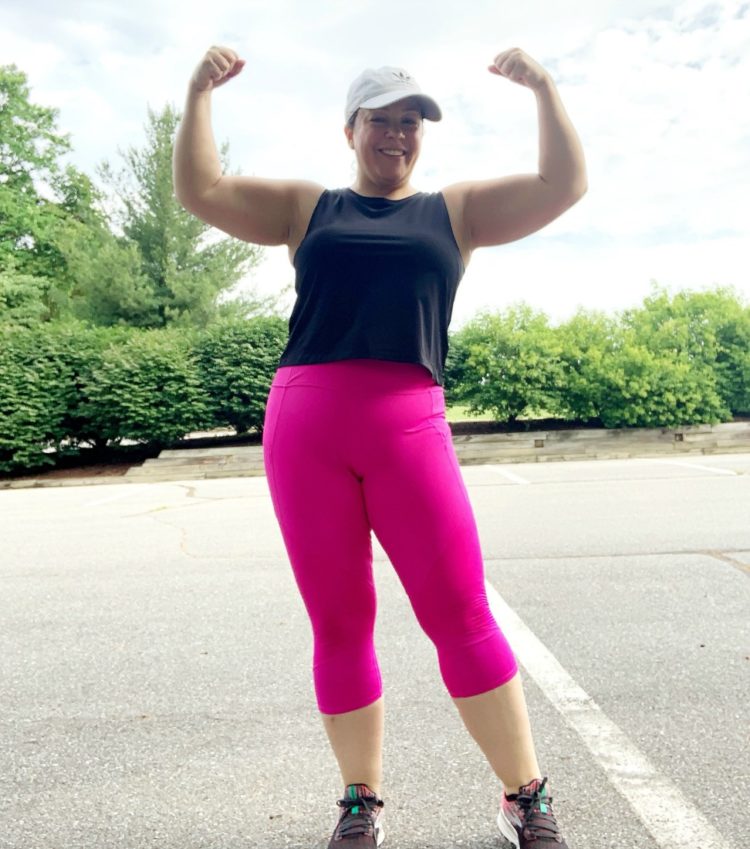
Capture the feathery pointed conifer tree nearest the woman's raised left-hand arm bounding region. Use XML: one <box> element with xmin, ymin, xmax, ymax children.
<box><xmin>99</xmin><ymin>106</ymin><xmax>276</xmax><ymax>327</ymax></box>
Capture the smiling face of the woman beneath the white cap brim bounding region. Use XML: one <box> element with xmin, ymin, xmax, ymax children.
<box><xmin>345</xmin><ymin>98</ymin><xmax>423</xmax><ymax>190</ymax></box>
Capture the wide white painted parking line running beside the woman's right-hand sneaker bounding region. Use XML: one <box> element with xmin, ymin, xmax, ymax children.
<box><xmin>487</xmin><ymin>582</ymin><xmax>732</xmax><ymax>849</ymax></box>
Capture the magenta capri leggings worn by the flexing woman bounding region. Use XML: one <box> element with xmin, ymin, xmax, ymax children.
<box><xmin>263</xmin><ymin>359</ymin><xmax>517</xmax><ymax>714</ymax></box>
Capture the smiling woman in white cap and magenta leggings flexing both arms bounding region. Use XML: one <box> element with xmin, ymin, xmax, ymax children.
<box><xmin>174</xmin><ymin>47</ymin><xmax>586</xmax><ymax>849</ymax></box>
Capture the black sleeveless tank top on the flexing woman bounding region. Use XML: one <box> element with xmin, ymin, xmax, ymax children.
<box><xmin>279</xmin><ymin>189</ymin><xmax>464</xmax><ymax>384</ymax></box>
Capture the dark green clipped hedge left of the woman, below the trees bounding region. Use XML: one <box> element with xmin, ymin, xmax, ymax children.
<box><xmin>0</xmin><ymin>317</ymin><xmax>286</xmax><ymax>473</ymax></box>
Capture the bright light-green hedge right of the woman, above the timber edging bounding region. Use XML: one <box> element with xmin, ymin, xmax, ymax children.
<box><xmin>446</xmin><ymin>288</ymin><xmax>750</xmax><ymax>427</ymax></box>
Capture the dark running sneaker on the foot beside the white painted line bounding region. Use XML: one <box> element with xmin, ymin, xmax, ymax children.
<box><xmin>497</xmin><ymin>778</ymin><xmax>568</xmax><ymax>849</ymax></box>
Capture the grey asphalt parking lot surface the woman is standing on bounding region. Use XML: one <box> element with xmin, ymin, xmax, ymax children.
<box><xmin>0</xmin><ymin>453</ymin><xmax>750</xmax><ymax>849</ymax></box>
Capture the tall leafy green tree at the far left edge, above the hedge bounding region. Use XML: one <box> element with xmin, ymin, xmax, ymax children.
<box><xmin>0</xmin><ymin>65</ymin><xmax>140</xmax><ymax>324</ymax></box>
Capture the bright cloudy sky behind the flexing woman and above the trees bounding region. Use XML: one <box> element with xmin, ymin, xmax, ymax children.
<box><xmin>0</xmin><ymin>0</ymin><xmax>750</xmax><ymax>329</ymax></box>
